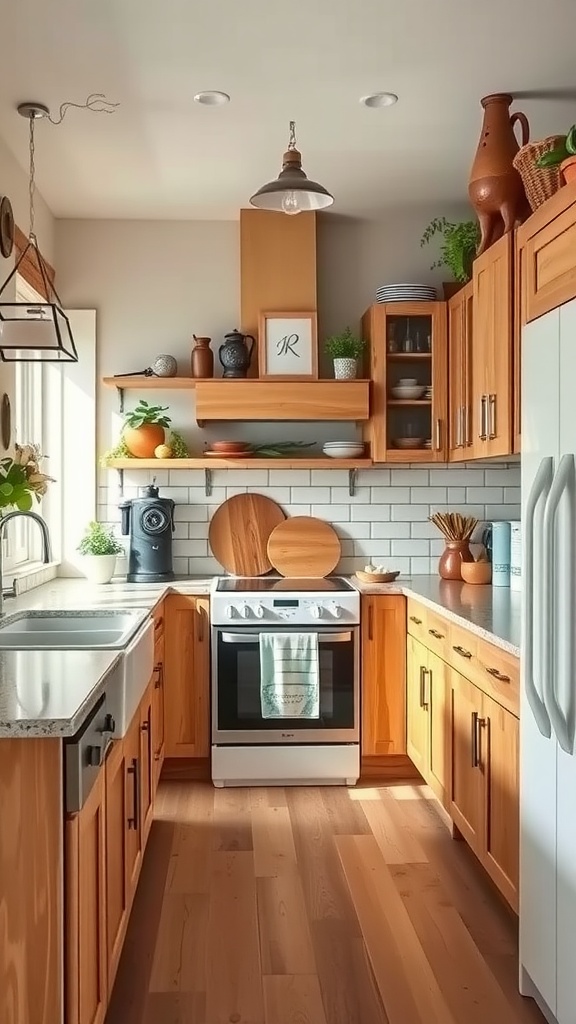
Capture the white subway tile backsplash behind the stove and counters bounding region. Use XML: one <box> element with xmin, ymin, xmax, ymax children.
<box><xmin>98</xmin><ymin>462</ymin><xmax>520</xmax><ymax>575</ymax></box>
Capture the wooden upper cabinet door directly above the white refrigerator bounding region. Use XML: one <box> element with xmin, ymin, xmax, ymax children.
<box><xmin>517</xmin><ymin>182</ymin><xmax>576</xmax><ymax>324</ymax></box>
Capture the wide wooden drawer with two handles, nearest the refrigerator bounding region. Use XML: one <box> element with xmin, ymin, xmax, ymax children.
<box><xmin>448</xmin><ymin>625</ymin><xmax>520</xmax><ymax>717</ymax></box>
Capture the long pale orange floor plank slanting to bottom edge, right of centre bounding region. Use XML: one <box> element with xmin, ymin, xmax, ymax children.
<box><xmin>336</xmin><ymin>836</ymin><xmax>456</xmax><ymax>1024</ymax></box>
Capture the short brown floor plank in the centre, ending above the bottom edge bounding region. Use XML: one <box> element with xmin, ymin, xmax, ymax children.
<box><xmin>256</xmin><ymin>873</ymin><xmax>316</xmax><ymax>975</ymax></box>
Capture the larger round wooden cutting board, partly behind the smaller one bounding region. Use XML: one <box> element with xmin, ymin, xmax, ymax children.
<box><xmin>208</xmin><ymin>494</ymin><xmax>285</xmax><ymax>575</ymax></box>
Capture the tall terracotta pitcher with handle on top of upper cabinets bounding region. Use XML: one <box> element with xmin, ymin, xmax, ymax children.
<box><xmin>468</xmin><ymin>92</ymin><xmax>530</xmax><ymax>256</ymax></box>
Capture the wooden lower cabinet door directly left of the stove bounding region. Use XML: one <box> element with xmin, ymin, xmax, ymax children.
<box><xmin>164</xmin><ymin>594</ymin><xmax>210</xmax><ymax>758</ymax></box>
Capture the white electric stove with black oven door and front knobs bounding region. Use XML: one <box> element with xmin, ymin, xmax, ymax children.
<box><xmin>211</xmin><ymin>577</ymin><xmax>360</xmax><ymax>786</ymax></box>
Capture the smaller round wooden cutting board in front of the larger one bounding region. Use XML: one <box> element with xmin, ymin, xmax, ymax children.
<box><xmin>268</xmin><ymin>515</ymin><xmax>341</xmax><ymax>577</ymax></box>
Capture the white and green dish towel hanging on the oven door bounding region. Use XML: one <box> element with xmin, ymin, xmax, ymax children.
<box><xmin>259</xmin><ymin>633</ymin><xmax>320</xmax><ymax>718</ymax></box>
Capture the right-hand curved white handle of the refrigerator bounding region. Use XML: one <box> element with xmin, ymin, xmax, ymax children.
<box><xmin>543</xmin><ymin>455</ymin><xmax>575</xmax><ymax>754</ymax></box>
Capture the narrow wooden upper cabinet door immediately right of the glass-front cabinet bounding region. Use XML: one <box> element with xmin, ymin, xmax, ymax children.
<box><xmin>448</xmin><ymin>281</ymin><xmax>474</xmax><ymax>462</ymax></box>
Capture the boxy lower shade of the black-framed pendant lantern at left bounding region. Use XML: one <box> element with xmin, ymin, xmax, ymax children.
<box><xmin>0</xmin><ymin>302</ymin><xmax>78</xmax><ymax>362</ymax></box>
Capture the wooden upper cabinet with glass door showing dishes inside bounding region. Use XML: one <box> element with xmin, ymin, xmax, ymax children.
<box><xmin>362</xmin><ymin>302</ymin><xmax>448</xmax><ymax>462</ymax></box>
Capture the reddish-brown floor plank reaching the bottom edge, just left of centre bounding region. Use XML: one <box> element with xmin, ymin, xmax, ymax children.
<box><xmin>205</xmin><ymin>851</ymin><xmax>264</xmax><ymax>1024</ymax></box>
